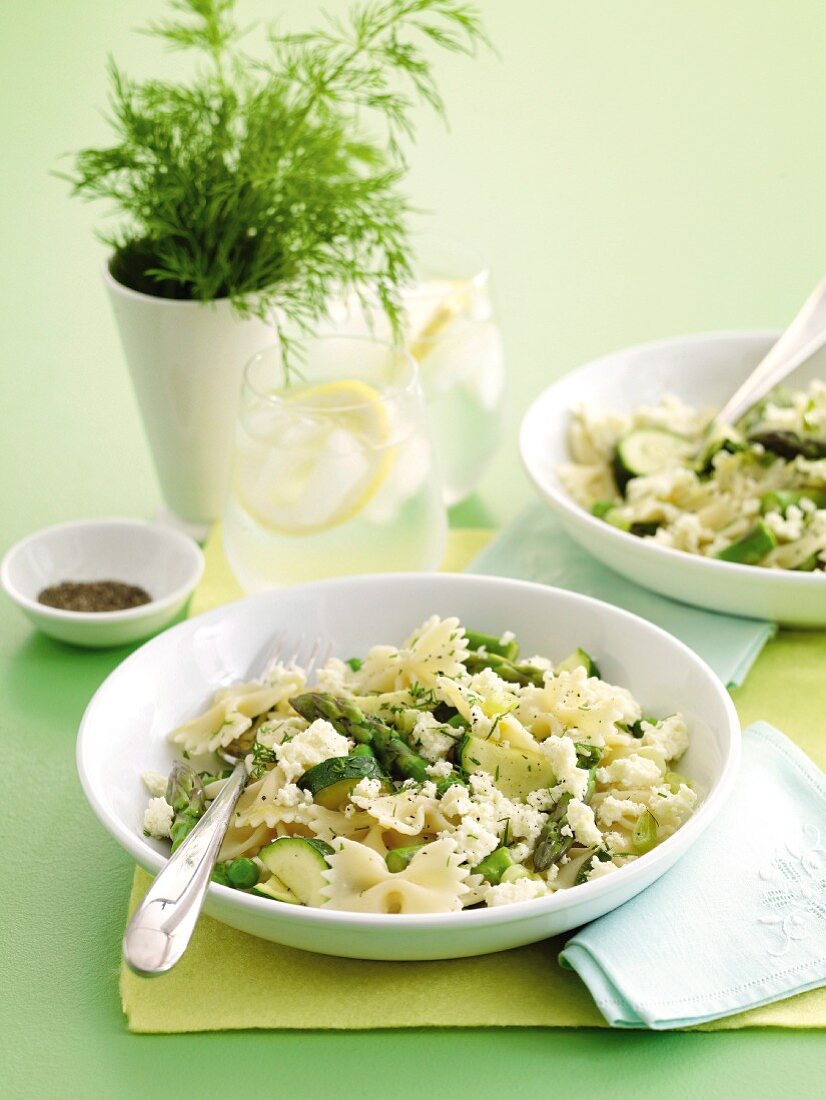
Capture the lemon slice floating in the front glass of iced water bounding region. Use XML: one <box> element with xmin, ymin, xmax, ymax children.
<box><xmin>233</xmin><ymin>378</ymin><xmax>394</xmax><ymax>535</ymax></box>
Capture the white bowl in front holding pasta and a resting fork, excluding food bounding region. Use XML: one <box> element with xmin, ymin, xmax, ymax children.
<box><xmin>77</xmin><ymin>574</ymin><xmax>740</xmax><ymax>960</ymax></box>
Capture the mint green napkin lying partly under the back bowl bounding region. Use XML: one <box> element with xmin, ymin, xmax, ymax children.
<box><xmin>467</xmin><ymin>502</ymin><xmax>777</xmax><ymax>688</ymax></box>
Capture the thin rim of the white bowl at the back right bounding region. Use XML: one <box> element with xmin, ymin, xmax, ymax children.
<box><xmin>519</xmin><ymin>329</ymin><xmax>826</xmax><ymax>587</ymax></box>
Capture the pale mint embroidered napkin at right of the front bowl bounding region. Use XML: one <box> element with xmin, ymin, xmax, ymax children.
<box><xmin>560</xmin><ymin>722</ymin><xmax>826</xmax><ymax>1031</ymax></box>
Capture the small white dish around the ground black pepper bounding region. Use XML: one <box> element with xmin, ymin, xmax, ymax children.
<box><xmin>0</xmin><ymin>519</ymin><xmax>203</xmax><ymax>648</ymax></box>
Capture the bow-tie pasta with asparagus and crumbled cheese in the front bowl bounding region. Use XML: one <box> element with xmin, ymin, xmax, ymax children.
<box><xmin>144</xmin><ymin>616</ymin><xmax>700</xmax><ymax>914</ymax></box>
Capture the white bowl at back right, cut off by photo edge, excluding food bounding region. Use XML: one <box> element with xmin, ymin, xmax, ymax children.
<box><xmin>519</xmin><ymin>332</ymin><xmax>826</xmax><ymax>627</ymax></box>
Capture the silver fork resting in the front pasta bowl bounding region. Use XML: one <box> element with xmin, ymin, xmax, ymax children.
<box><xmin>123</xmin><ymin>635</ymin><xmax>330</xmax><ymax>977</ymax></box>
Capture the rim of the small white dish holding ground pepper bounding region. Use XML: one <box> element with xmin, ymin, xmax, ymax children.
<box><xmin>0</xmin><ymin>517</ymin><xmax>205</xmax><ymax>623</ymax></box>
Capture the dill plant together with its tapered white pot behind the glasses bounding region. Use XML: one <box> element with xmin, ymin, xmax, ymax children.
<box><xmin>66</xmin><ymin>0</ymin><xmax>483</xmax><ymax>526</ymax></box>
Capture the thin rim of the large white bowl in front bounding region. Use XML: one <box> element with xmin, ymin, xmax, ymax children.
<box><xmin>76</xmin><ymin>573</ymin><xmax>740</xmax><ymax>930</ymax></box>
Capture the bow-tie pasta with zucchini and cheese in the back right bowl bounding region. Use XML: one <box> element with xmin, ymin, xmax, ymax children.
<box><xmin>560</xmin><ymin>381</ymin><xmax>826</xmax><ymax>572</ymax></box>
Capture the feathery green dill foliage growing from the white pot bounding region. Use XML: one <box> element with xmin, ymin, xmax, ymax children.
<box><xmin>66</xmin><ymin>0</ymin><xmax>485</xmax><ymax>374</ymax></box>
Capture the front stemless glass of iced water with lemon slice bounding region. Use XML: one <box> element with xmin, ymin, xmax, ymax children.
<box><xmin>223</xmin><ymin>334</ymin><xmax>447</xmax><ymax>592</ymax></box>
